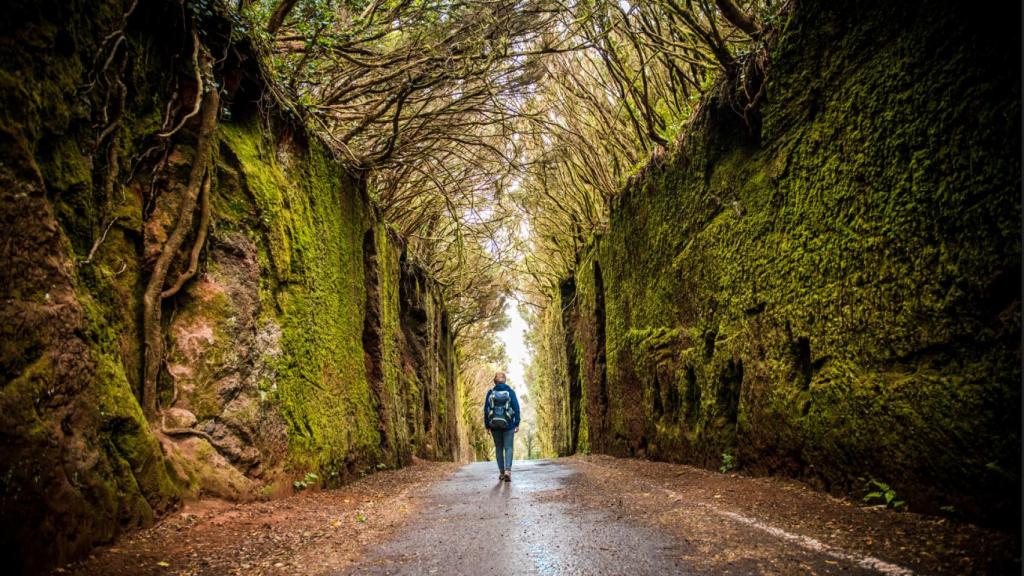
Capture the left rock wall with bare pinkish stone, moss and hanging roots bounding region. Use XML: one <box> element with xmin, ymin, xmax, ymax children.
<box><xmin>0</xmin><ymin>1</ymin><xmax>460</xmax><ymax>573</ymax></box>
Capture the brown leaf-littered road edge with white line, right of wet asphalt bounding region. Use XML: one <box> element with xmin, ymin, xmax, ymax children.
<box><xmin>557</xmin><ymin>456</ymin><xmax>1021</xmax><ymax>574</ymax></box>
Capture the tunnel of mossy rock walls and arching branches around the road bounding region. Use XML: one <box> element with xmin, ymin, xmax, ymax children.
<box><xmin>0</xmin><ymin>0</ymin><xmax>1021</xmax><ymax>566</ymax></box>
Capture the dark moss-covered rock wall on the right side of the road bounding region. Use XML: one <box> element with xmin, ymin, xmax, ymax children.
<box><xmin>538</xmin><ymin>0</ymin><xmax>1021</xmax><ymax>529</ymax></box>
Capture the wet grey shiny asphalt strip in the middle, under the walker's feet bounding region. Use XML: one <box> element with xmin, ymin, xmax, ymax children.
<box><xmin>341</xmin><ymin>460</ymin><xmax>691</xmax><ymax>575</ymax></box>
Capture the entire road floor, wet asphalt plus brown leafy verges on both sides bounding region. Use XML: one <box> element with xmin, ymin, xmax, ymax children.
<box><xmin>68</xmin><ymin>455</ymin><xmax>1021</xmax><ymax>576</ymax></box>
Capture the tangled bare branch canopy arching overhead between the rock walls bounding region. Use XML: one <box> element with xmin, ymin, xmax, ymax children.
<box><xmin>239</xmin><ymin>0</ymin><xmax>781</xmax><ymax>334</ymax></box>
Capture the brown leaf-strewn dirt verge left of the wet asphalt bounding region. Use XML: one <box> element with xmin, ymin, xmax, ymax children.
<box><xmin>55</xmin><ymin>460</ymin><xmax>460</xmax><ymax>576</ymax></box>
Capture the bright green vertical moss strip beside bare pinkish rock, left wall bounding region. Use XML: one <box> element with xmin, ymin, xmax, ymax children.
<box><xmin>221</xmin><ymin>119</ymin><xmax>385</xmax><ymax>481</ymax></box>
